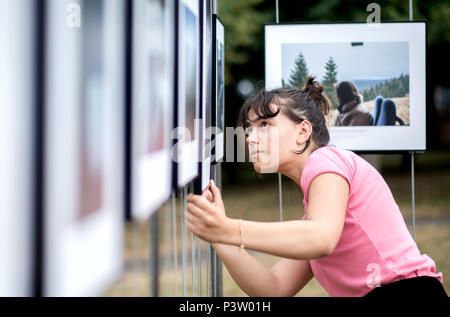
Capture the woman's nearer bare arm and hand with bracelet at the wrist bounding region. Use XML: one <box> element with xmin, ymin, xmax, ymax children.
<box><xmin>187</xmin><ymin>173</ymin><xmax>349</xmax><ymax>259</ymax></box>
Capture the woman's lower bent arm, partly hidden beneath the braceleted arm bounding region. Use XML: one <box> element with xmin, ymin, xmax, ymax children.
<box><xmin>212</xmin><ymin>243</ymin><xmax>313</xmax><ymax>297</ymax></box>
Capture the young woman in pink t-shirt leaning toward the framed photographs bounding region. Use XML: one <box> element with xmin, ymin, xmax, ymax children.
<box><xmin>186</xmin><ymin>78</ymin><xmax>446</xmax><ymax>296</ymax></box>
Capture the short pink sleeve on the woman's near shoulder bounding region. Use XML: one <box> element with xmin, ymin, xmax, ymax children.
<box><xmin>300</xmin><ymin>147</ymin><xmax>354</xmax><ymax>200</ymax></box>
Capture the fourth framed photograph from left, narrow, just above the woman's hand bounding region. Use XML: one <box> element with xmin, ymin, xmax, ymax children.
<box><xmin>172</xmin><ymin>0</ymin><xmax>201</xmax><ymax>187</ymax></box>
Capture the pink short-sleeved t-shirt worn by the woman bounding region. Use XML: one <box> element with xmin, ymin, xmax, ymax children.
<box><xmin>301</xmin><ymin>146</ymin><xmax>443</xmax><ymax>296</ymax></box>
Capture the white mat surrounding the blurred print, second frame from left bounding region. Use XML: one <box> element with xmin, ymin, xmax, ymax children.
<box><xmin>44</xmin><ymin>0</ymin><xmax>124</xmax><ymax>296</ymax></box>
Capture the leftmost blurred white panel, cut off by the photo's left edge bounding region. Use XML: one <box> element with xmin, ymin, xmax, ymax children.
<box><xmin>0</xmin><ymin>0</ymin><xmax>38</xmax><ymax>297</ymax></box>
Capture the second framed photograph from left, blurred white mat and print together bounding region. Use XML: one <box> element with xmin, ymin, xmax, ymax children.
<box><xmin>43</xmin><ymin>0</ymin><xmax>125</xmax><ymax>296</ymax></box>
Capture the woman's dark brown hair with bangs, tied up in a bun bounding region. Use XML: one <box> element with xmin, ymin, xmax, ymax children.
<box><xmin>238</xmin><ymin>77</ymin><xmax>330</xmax><ymax>154</ymax></box>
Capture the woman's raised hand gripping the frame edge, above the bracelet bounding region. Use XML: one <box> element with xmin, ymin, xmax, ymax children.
<box><xmin>185</xmin><ymin>181</ymin><xmax>229</xmax><ymax>242</ymax></box>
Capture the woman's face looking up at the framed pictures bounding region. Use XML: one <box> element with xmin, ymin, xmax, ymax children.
<box><xmin>246</xmin><ymin>104</ymin><xmax>310</xmax><ymax>173</ymax></box>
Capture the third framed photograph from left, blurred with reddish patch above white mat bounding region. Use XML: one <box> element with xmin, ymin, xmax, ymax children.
<box><xmin>130</xmin><ymin>0</ymin><xmax>175</xmax><ymax>220</ymax></box>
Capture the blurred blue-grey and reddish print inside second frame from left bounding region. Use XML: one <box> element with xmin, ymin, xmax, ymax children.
<box><xmin>79</xmin><ymin>1</ymin><xmax>105</xmax><ymax>218</ymax></box>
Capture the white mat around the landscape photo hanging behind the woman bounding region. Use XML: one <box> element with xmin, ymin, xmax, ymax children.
<box><xmin>265</xmin><ymin>22</ymin><xmax>426</xmax><ymax>151</ymax></box>
